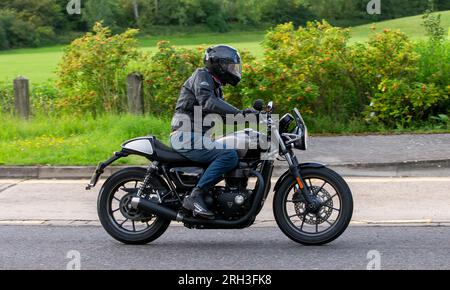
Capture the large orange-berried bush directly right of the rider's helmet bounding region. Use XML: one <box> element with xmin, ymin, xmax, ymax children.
<box><xmin>256</xmin><ymin>21</ymin><xmax>363</xmax><ymax>118</ymax></box>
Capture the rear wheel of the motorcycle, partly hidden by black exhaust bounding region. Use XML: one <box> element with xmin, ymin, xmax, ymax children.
<box><xmin>97</xmin><ymin>167</ymin><xmax>170</xmax><ymax>244</ymax></box>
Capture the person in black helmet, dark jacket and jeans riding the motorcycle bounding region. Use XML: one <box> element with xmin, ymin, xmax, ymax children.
<box><xmin>170</xmin><ymin>45</ymin><xmax>256</xmax><ymax>218</ymax></box>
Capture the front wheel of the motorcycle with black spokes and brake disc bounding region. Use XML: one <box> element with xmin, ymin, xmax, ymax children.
<box><xmin>273</xmin><ymin>167</ymin><xmax>353</xmax><ymax>245</ymax></box>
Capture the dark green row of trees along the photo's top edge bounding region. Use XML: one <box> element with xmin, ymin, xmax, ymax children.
<box><xmin>0</xmin><ymin>0</ymin><xmax>450</xmax><ymax>49</ymax></box>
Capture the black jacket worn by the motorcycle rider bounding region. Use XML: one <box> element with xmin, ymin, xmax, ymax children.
<box><xmin>172</xmin><ymin>68</ymin><xmax>240</xmax><ymax>132</ymax></box>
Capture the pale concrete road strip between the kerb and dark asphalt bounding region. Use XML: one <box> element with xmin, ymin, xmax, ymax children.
<box><xmin>0</xmin><ymin>177</ymin><xmax>450</xmax><ymax>225</ymax></box>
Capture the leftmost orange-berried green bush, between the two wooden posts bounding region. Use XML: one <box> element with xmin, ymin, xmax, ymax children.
<box><xmin>57</xmin><ymin>23</ymin><xmax>138</xmax><ymax>114</ymax></box>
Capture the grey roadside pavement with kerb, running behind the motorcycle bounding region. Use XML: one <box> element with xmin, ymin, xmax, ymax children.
<box><xmin>0</xmin><ymin>134</ymin><xmax>450</xmax><ymax>179</ymax></box>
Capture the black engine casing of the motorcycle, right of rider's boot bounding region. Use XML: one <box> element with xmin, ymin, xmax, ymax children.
<box><xmin>211</xmin><ymin>179</ymin><xmax>253</xmax><ymax>220</ymax></box>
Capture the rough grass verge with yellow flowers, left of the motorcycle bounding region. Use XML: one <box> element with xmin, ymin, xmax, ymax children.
<box><xmin>0</xmin><ymin>115</ymin><xmax>170</xmax><ymax>165</ymax></box>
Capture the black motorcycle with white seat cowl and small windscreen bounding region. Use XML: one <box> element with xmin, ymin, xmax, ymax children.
<box><xmin>86</xmin><ymin>100</ymin><xmax>353</xmax><ymax>245</ymax></box>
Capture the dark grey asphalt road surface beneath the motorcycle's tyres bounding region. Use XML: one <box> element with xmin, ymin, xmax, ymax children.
<box><xmin>0</xmin><ymin>226</ymin><xmax>450</xmax><ymax>270</ymax></box>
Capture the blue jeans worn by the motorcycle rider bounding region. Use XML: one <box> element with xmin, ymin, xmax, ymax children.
<box><xmin>170</xmin><ymin>132</ymin><xmax>239</xmax><ymax>190</ymax></box>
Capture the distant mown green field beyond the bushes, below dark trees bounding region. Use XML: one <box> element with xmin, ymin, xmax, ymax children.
<box><xmin>0</xmin><ymin>11</ymin><xmax>450</xmax><ymax>84</ymax></box>
